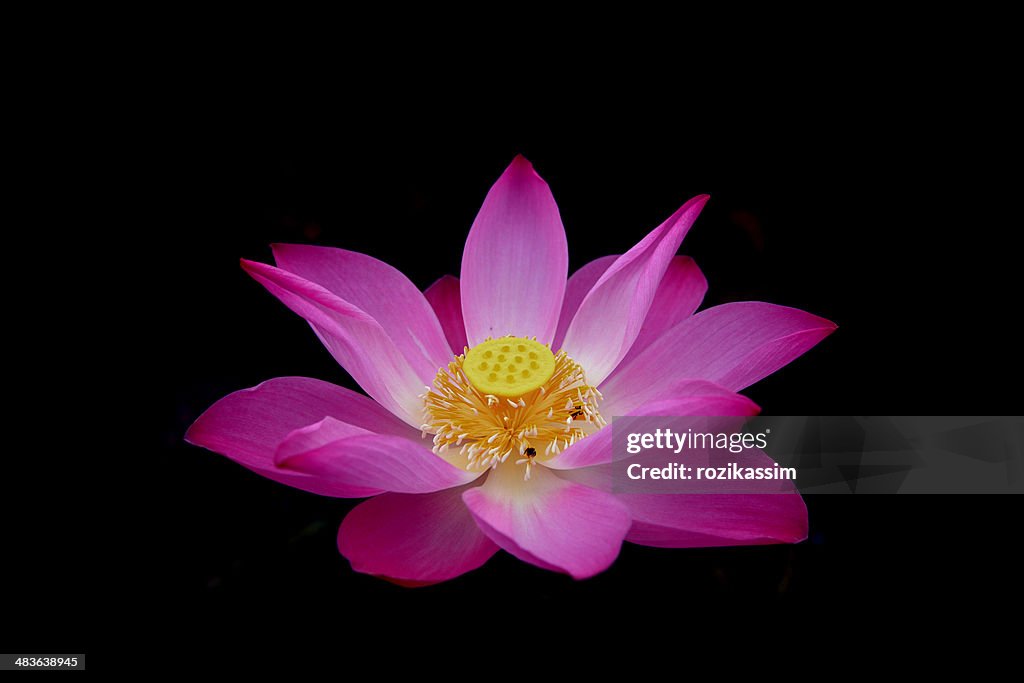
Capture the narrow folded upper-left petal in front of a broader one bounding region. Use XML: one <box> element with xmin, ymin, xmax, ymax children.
<box><xmin>242</xmin><ymin>259</ymin><xmax>423</xmax><ymax>426</ymax></box>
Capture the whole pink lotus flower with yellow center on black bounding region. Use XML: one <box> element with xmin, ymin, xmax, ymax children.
<box><xmin>186</xmin><ymin>157</ymin><xmax>836</xmax><ymax>585</ymax></box>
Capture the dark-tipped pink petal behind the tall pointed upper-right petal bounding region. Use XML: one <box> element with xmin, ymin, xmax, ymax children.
<box><xmin>622</xmin><ymin>256</ymin><xmax>708</xmax><ymax>364</ymax></box>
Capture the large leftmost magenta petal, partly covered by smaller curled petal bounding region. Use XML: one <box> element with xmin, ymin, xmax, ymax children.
<box><xmin>185</xmin><ymin>377</ymin><xmax>420</xmax><ymax>496</ymax></box>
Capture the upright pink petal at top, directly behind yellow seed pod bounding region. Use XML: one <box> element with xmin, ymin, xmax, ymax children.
<box><xmin>461</xmin><ymin>156</ymin><xmax>568</xmax><ymax>346</ymax></box>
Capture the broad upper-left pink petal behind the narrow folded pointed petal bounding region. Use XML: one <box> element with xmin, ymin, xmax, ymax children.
<box><xmin>272</xmin><ymin>244</ymin><xmax>452</xmax><ymax>379</ymax></box>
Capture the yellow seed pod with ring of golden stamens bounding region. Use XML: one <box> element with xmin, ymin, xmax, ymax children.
<box><xmin>422</xmin><ymin>337</ymin><xmax>606</xmax><ymax>479</ymax></box>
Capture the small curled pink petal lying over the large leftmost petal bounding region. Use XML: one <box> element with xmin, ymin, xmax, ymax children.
<box><xmin>274</xmin><ymin>418</ymin><xmax>480</xmax><ymax>497</ymax></box>
